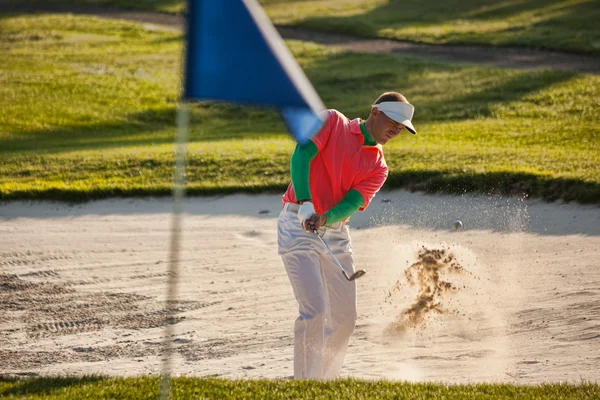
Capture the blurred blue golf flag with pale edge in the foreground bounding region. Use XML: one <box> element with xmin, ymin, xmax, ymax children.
<box><xmin>184</xmin><ymin>0</ymin><xmax>325</xmax><ymax>143</ymax></box>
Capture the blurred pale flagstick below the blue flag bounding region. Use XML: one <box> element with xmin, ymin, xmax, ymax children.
<box><xmin>160</xmin><ymin>101</ymin><xmax>190</xmax><ymax>400</ymax></box>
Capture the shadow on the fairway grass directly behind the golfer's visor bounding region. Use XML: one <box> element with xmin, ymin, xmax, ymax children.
<box><xmin>307</xmin><ymin>53</ymin><xmax>577</xmax><ymax>124</ymax></box>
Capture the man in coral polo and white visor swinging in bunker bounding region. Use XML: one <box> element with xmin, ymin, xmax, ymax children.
<box><xmin>277</xmin><ymin>92</ymin><xmax>417</xmax><ymax>379</ymax></box>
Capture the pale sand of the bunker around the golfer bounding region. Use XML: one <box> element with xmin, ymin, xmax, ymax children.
<box><xmin>0</xmin><ymin>191</ymin><xmax>600</xmax><ymax>384</ymax></box>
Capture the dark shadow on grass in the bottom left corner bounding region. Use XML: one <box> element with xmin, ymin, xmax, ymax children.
<box><xmin>0</xmin><ymin>376</ymin><xmax>104</xmax><ymax>397</ymax></box>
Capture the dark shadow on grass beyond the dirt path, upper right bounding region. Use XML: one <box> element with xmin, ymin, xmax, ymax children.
<box><xmin>296</xmin><ymin>0</ymin><xmax>600</xmax><ymax>54</ymax></box>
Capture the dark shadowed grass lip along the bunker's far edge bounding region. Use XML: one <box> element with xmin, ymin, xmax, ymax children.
<box><xmin>0</xmin><ymin>171</ymin><xmax>600</xmax><ymax>204</ymax></box>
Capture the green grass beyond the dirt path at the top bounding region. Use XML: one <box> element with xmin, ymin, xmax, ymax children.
<box><xmin>35</xmin><ymin>0</ymin><xmax>600</xmax><ymax>55</ymax></box>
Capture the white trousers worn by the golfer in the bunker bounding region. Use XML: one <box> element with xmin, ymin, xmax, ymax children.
<box><xmin>277</xmin><ymin>205</ymin><xmax>356</xmax><ymax>379</ymax></box>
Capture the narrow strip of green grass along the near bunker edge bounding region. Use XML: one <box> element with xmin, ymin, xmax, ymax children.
<box><xmin>0</xmin><ymin>377</ymin><xmax>600</xmax><ymax>400</ymax></box>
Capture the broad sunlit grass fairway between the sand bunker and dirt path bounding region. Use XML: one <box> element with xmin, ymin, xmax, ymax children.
<box><xmin>0</xmin><ymin>15</ymin><xmax>600</xmax><ymax>202</ymax></box>
